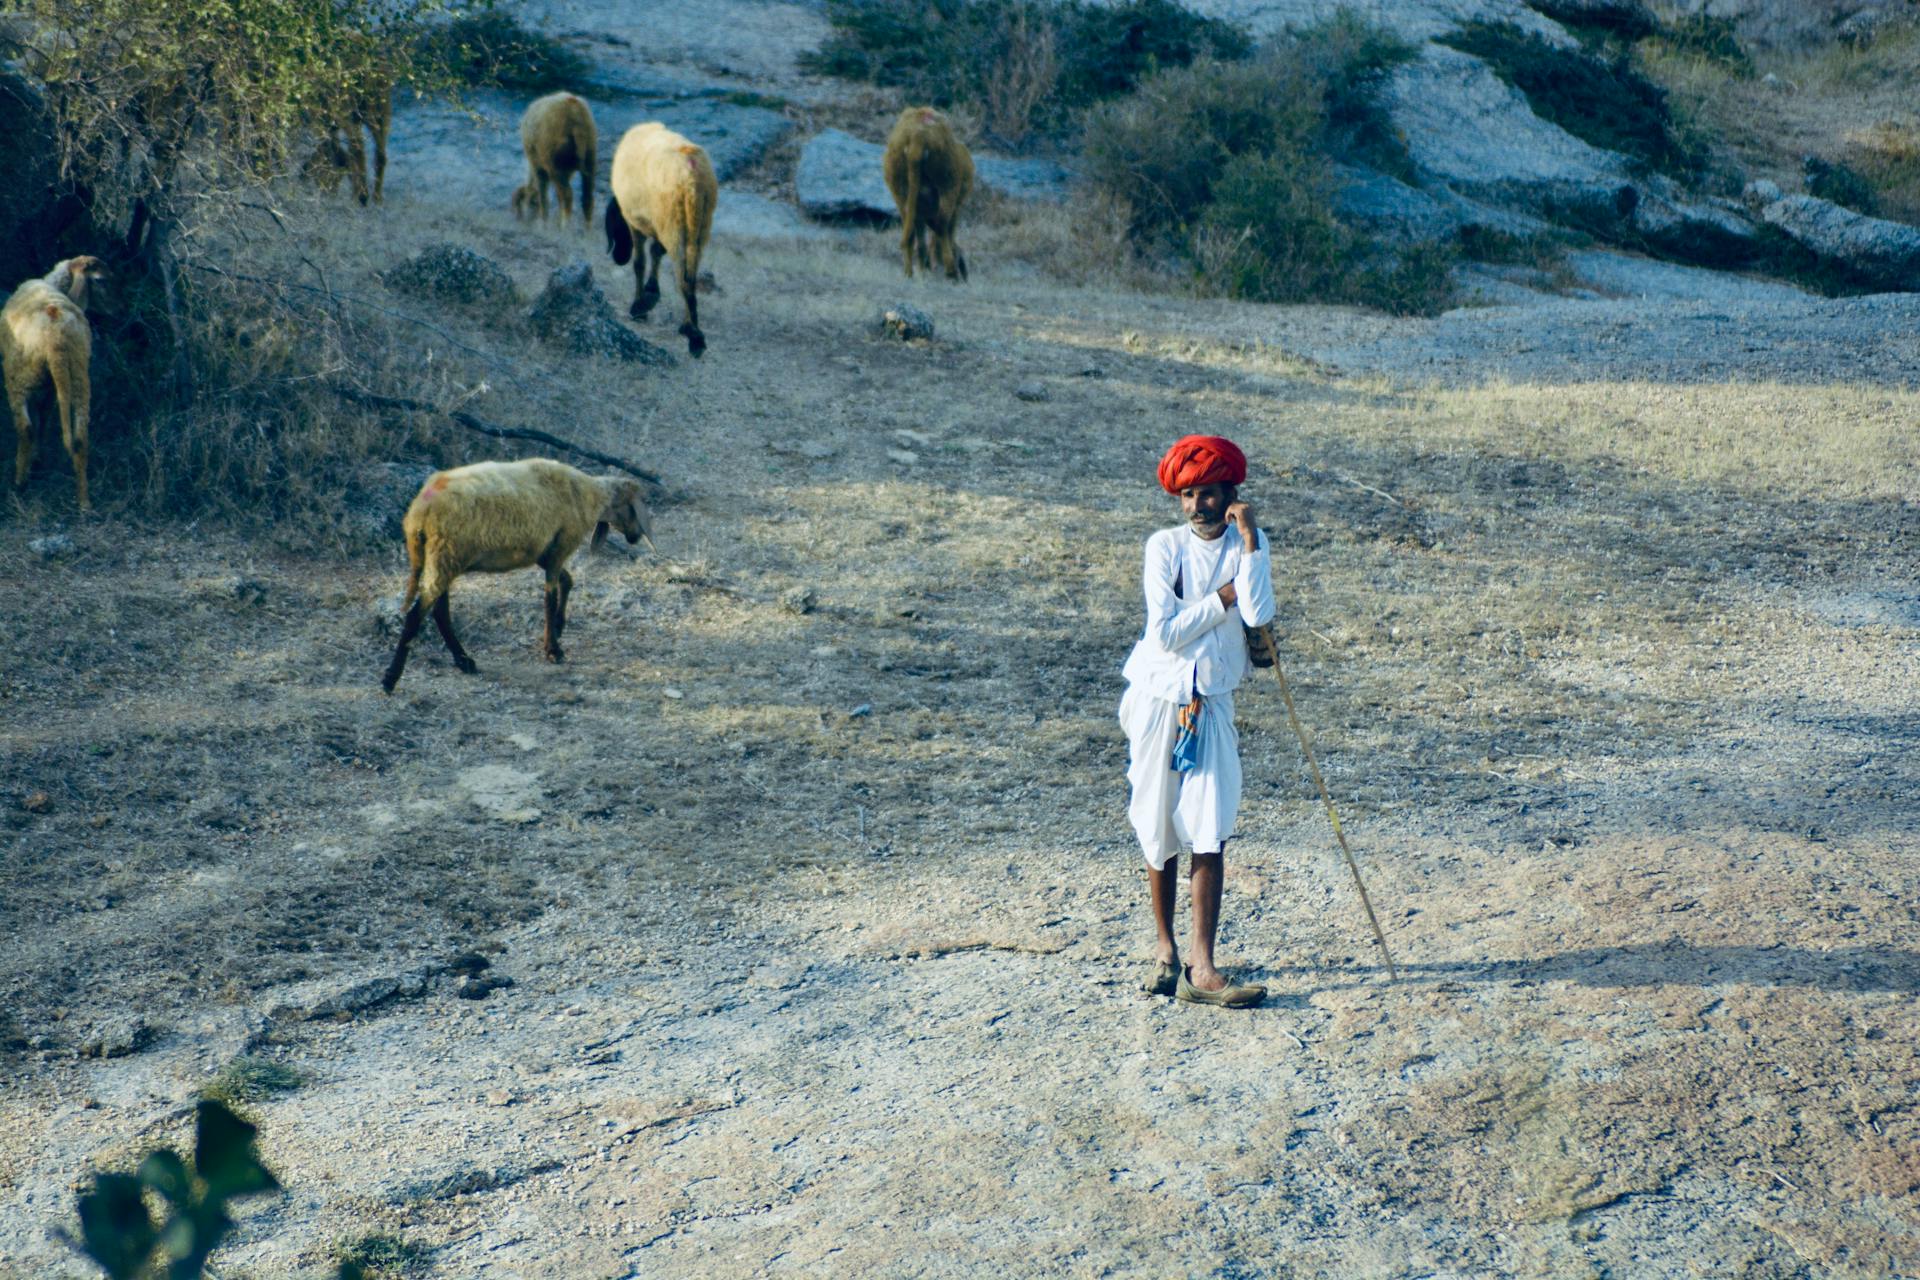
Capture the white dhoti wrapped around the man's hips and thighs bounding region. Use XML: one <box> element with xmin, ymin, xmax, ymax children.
<box><xmin>1119</xmin><ymin>685</ymin><xmax>1240</xmax><ymax>871</ymax></box>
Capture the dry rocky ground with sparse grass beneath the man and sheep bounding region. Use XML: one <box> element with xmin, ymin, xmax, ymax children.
<box><xmin>0</xmin><ymin>4</ymin><xmax>1920</xmax><ymax>1278</ymax></box>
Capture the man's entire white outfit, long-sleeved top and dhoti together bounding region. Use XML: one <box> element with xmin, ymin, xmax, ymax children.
<box><xmin>1119</xmin><ymin>524</ymin><xmax>1273</xmax><ymax>871</ymax></box>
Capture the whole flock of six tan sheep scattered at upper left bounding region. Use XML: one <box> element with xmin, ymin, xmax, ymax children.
<box><xmin>0</xmin><ymin>86</ymin><xmax>973</xmax><ymax>693</ymax></box>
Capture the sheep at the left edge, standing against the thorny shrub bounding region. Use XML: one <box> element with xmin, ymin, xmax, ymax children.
<box><xmin>0</xmin><ymin>255</ymin><xmax>108</xmax><ymax>510</ymax></box>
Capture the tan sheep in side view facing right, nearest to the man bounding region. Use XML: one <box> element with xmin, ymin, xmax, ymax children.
<box><xmin>380</xmin><ymin>459</ymin><xmax>653</xmax><ymax>693</ymax></box>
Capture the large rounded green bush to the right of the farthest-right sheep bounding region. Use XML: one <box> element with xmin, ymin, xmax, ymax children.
<box><xmin>1083</xmin><ymin>13</ymin><xmax>1455</xmax><ymax>315</ymax></box>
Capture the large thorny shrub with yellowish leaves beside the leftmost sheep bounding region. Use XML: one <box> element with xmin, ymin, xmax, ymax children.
<box><xmin>0</xmin><ymin>0</ymin><xmax>490</xmax><ymax>518</ymax></box>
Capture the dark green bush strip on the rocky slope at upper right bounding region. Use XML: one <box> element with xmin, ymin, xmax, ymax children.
<box><xmin>1442</xmin><ymin>21</ymin><xmax>1707</xmax><ymax>178</ymax></box>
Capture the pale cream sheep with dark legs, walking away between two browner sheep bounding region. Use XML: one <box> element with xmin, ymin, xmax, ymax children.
<box><xmin>607</xmin><ymin>123</ymin><xmax>720</xmax><ymax>357</ymax></box>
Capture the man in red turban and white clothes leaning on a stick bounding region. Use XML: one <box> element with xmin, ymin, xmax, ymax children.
<box><xmin>1119</xmin><ymin>436</ymin><xmax>1273</xmax><ymax>1009</ymax></box>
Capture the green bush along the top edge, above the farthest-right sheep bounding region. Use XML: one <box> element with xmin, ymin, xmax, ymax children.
<box><xmin>801</xmin><ymin>0</ymin><xmax>1254</xmax><ymax>142</ymax></box>
